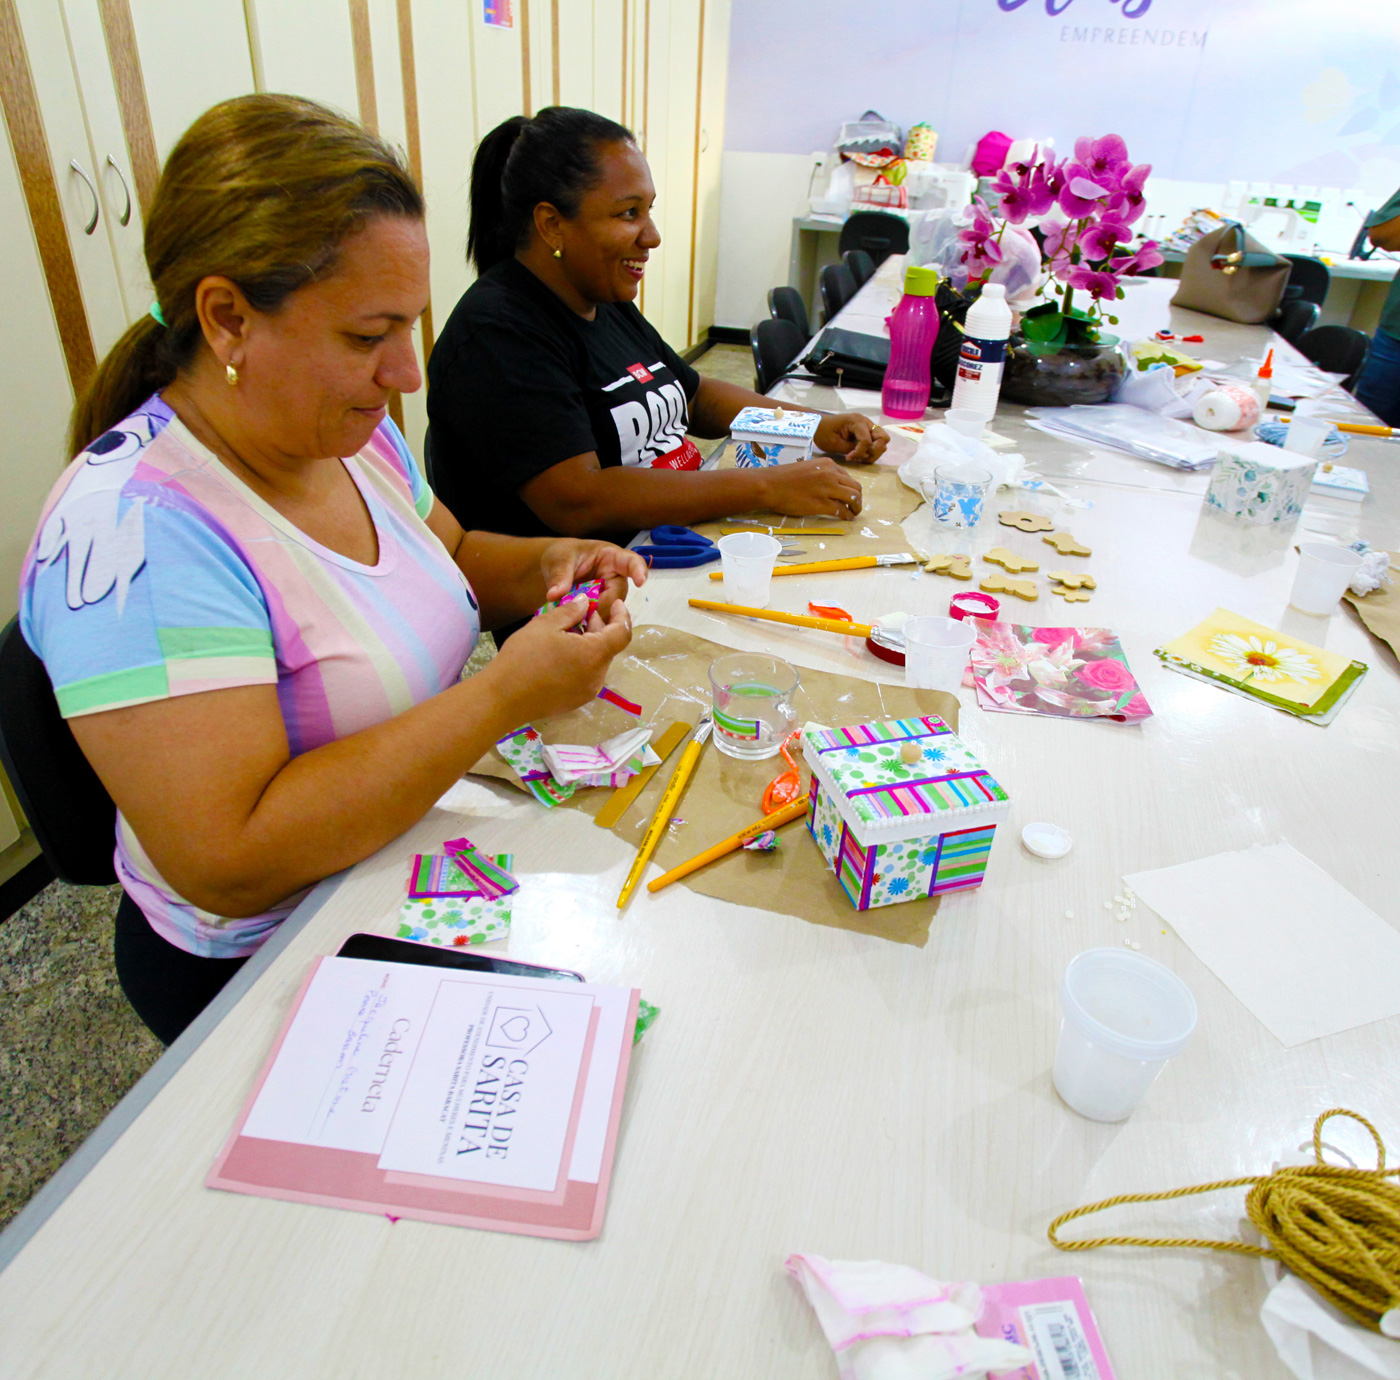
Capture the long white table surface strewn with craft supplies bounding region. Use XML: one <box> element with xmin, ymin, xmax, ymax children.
<box><xmin>0</xmin><ymin>269</ymin><xmax>1400</xmax><ymax>1380</ymax></box>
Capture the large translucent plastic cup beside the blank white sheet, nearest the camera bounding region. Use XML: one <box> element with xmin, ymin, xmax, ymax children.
<box><xmin>1054</xmin><ymin>949</ymin><xmax>1196</xmax><ymax>1121</ymax></box>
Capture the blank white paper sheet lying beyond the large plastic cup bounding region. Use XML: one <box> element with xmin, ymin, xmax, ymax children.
<box><xmin>1123</xmin><ymin>844</ymin><xmax>1400</xmax><ymax>1045</ymax></box>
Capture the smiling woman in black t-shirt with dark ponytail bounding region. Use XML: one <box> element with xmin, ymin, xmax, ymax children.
<box><xmin>428</xmin><ymin>106</ymin><xmax>889</xmax><ymax>537</ymax></box>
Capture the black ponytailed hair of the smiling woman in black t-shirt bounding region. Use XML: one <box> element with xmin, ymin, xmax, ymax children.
<box><xmin>466</xmin><ymin>105</ymin><xmax>634</xmax><ymax>273</ymax></box>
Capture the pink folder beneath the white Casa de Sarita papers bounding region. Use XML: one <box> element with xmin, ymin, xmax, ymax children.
<box><xmin>204</xmin><ymin>959</ymin><xmax>640</xmax><ymax>1241</ymax></box>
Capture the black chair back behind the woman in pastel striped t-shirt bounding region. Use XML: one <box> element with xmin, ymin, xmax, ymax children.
<box><xmin>0</xmin><ymin>619</ymin><xmax>116</xmax><ymax>886</ymax></box>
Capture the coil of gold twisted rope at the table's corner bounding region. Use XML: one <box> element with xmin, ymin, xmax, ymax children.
<box><xmin>1047</xmin><ymin>1107</ymin><xmax>1400</xmax><ymax>1332</ymax></box>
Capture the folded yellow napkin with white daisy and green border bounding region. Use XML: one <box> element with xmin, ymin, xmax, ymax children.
<box><xmin>1156</xmin><ymin>609</ymin><xmax>1368</xmax><ymax>722</ymax></box>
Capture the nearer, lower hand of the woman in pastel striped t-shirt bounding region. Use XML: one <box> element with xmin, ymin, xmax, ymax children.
<box><xmin>479</xmin><ymin>599</ymin><xmax>631</xmax><ymax>725</ymax></box>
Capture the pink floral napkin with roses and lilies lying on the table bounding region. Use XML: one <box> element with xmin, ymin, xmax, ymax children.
<box><xmin>972</xmin><ymin>619</ymin><xmax>1152</xmax><ymax>724</ymax></box>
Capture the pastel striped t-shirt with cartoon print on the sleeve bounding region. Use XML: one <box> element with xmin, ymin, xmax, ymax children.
<box><xmin>20</xmin><ymin>395</ymin><xmax>479</xmax><ymax>959</ymax></box>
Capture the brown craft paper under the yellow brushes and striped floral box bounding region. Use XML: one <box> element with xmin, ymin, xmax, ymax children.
<box><xmin>472</xmin><ymin>624</ymin><xmax>958</xmax><ymax>946</ymax></box>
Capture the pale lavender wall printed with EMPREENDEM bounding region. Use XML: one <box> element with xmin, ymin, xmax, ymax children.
<box><xmin>715</xmin><ymin>0</ymin><xmax>1400</xmax><ymax>328</ymax></box>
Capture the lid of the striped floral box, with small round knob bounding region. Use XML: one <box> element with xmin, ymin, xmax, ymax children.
<box><xmin>802</xmin><ymin>714</ymin><xmax>1011</xmax><ymax>847</ymax></box>
